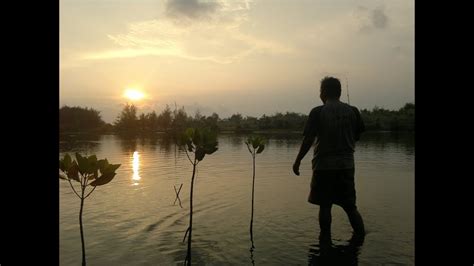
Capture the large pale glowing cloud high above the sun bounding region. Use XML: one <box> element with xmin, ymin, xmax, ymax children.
<box><xmin>82</xmin><ymin>0</ymin><xmax>293</xmax><ymax>64</ymax></box>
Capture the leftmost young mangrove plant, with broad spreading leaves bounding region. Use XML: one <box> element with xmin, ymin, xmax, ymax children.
<box><xmin>59</xmin><ymin>153</ymin><xmax>120</xmax><ymax>266</ymax></box>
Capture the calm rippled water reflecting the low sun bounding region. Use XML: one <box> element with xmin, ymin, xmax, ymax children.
<box><xmin>59</xmin><ymin>133</ymin><xmax>415</xmax><ymax>265</ymax></box>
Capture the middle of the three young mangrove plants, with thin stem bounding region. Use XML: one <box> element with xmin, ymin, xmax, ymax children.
<box><xmin>178</xmin><ymin>128</ymin><xmax>217</xmax><ymax>265</ymax></box>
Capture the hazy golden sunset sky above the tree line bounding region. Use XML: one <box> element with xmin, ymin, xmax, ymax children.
<box><xmin>60</xmin><ymin>0</ymin><xmax>414</xmax><ymax>122</ymax></box>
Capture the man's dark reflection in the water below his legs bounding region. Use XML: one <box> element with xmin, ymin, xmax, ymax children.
<box><xmin>308</xmin><ymin>235</ymin><xmax>364</xmax><ymax>266</ymax></box>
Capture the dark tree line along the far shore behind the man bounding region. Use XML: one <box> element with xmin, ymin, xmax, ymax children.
<box><xmin>59</xmin><ymin>103</ymin><xmax>415</xmax><ymax>134</ymax></box>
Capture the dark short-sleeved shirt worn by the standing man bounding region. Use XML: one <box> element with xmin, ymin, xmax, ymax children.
<box><xmin>303</xmin><ymin>101</ymin><xmax>365</xmax><ymax>170</ymax></box>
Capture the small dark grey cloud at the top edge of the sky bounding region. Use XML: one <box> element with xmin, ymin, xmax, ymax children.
<box><xmin>165</xmin><ymin>0</ymin><xmax>221</xmax><ymax>19</ymax></box>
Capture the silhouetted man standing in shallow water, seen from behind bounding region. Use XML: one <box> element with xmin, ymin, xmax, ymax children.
<box><xmin>293</xmin><ymin>77</ymin><xmax>365</xmax><ymax>237</ymax></box>
